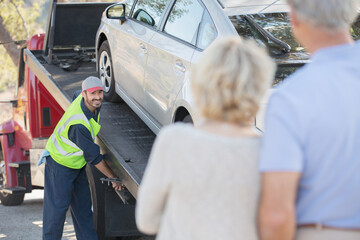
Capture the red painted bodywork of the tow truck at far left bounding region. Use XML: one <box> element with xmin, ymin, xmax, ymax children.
<box><xmin>0</xmin><ymin>34</ymin><xmax>64</xmax><ymax>197</ymax></box>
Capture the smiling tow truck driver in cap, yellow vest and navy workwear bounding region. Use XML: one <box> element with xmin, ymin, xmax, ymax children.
<box><xmin>43</xmin><ymin>77</ymin><xmax>122</xmax><ymax>240</ymax></box>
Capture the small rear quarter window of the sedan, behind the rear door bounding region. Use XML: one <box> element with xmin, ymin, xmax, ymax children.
<box><xmin>196</xmin><ymin>10</ymin><xmax>217</xmax><ymax>49</ymax></box>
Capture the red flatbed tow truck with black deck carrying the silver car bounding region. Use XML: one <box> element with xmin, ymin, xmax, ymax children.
<box><xmin>0</xmin><ymin>0</ymin><xmax>155</xmax><ymax>239</ymax></box>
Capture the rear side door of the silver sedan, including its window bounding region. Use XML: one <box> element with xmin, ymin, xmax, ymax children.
<box><xmin>145</xmin><ymin>0</ymin><xmax>214</xmax><ymax>127</ymax></box>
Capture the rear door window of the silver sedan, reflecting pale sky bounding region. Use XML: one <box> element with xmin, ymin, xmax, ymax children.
<box><xmin>164</xmin><ymin>0</ymin><xmax>204</xmax><ymax>45</ymax></box>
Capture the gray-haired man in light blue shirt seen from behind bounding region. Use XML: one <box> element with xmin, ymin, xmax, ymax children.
<box><xmin>259</xmin><ymin>0</ymin><xmax>360</xmax><ymax>240</ymax></box>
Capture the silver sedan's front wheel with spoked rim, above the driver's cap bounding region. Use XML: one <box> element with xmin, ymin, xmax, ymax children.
<box><xmin>98</xmin><ymin>41</ymin><xmax>121</xmax><ymax>102</ymax></box>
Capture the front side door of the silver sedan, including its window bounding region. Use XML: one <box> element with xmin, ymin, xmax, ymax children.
<box><xmin>108</xmin><ymin>0</ymin><xmax>169</xmax><ymax>107</ymax></box>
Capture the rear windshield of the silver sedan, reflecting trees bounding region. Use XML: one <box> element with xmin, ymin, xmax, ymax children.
<box><xmin>229</xmin><ymin>13</ymin><xmax>360</xmax><ymax>85</ymax></box>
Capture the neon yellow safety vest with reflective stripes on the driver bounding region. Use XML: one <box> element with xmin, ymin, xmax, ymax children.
<box><xmin>45</xmin><ymin>94</ymin><xmax>101</xmax><ymax>169</ymax></box>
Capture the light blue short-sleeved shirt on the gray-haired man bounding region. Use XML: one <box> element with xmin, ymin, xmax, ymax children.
<box><xmin>260</xmin><ymin>42</ymin><xmax>360</xmax><ymax>228</ymax></box>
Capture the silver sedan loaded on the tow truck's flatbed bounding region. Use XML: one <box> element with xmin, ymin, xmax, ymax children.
<box><xmin>96</xmin><ymin>0</ymin><xmax>308</xmax><ymax>133</ymax></box>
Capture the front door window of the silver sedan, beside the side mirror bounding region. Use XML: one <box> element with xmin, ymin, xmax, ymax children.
<box><xmin>132</xmin><ymin>0</ymin><xmax>167</xmax><ymax>27</ymax></box>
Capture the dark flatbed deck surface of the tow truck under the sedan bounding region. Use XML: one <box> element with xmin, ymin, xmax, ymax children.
<box><xmin>25</xmin><ymin>51</ymin><xmax>156</xmax><ymax>198</ymax></box>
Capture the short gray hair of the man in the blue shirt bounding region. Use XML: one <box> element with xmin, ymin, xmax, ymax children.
<box><xmin>287</xmin><ymin>0</ymin><xmax>360</xmax><ymax>32</ymax></box>
